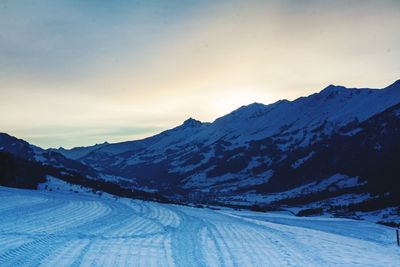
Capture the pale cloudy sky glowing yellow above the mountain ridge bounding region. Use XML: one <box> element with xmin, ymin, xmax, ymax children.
<box><xmin>0</xmin><ymin>0</ymin><xmax>400</xmax><ymax>148</ymax></box>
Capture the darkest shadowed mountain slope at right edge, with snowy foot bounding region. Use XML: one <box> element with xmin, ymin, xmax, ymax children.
<box><xmin>221</xmin><ymin>104</ymin><xmax>400</xmax><ymax>224</ymax></box>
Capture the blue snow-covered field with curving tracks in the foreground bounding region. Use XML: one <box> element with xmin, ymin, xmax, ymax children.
<box><xmin>0</xmin><ymin>187</ymin><xmax>400</xmax><ymax>266</ymax></box>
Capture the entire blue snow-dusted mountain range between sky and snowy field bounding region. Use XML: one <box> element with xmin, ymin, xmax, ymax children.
<box><xmin>0</xmin><ymin>80</ymin><xmax>400</xmax><ymax>223</ymax></box>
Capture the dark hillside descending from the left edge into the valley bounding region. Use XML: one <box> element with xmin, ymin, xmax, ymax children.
<box><xmin>0</xmin><ymin>133</ymin><xmax>165</xmax><ymax>202</ymax></box>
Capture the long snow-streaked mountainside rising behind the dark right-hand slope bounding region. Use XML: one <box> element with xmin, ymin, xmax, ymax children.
<box><xmin>54</xmin><ymin>81</ymin><xmax>400</xmax><ymax>194</ymax></box>
